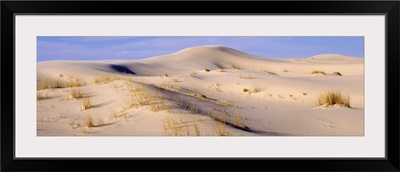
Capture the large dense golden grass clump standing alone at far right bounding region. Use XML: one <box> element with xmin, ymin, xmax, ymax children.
<box><xmin>317</xmin><ymin>91</ymin><xmax>350</xmax><ymax>107</ymax></box>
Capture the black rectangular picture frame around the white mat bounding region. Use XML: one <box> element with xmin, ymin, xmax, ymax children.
<box><xmin>0</xmin><ymin>1</ymin><xmax>400</xmax><ymax>171</ymax></box>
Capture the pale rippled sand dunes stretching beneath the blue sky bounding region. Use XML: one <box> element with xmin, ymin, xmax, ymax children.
<box><xmin>37</xmin><ymin>46</ymin><xmax>364</xmax><ymax>136</ymax></box>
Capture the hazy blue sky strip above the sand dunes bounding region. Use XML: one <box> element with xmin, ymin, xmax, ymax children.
<box><xmin>37</xmin><ymin>36</ymin><xmax>364</xmax><ymax>61</ymax></box>
